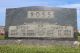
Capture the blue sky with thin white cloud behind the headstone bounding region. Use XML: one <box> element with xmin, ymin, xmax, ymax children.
<box><xmin>0</xmin><ymin>0</ymin><xmax>80</xmax><ymax>30</ymax></box>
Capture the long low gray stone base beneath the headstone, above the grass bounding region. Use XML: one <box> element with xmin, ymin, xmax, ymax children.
<box><xmin>0</xmin><ymin>39</ymin><xmax>74</xmax><ymax>46</ymax></box>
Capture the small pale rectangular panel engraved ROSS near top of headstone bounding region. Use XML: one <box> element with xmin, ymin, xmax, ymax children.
<box><xmin>27</xmin><ymin>11</ymin><xmax>54</xmax><ymax>19</ymax></box>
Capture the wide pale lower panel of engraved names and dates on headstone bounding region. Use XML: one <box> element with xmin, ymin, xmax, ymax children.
<box><xmin>9</xmin><ymin>23</ymin><xmax>73</xmax><ymax>38</ymax></box>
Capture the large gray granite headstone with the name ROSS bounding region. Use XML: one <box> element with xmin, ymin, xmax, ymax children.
<box><xmin>5</xmin><ymin>6</ymin><xmax>77</xmax><ymax>44</ymax></box>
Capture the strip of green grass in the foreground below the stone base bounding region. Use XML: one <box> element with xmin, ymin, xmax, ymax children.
<box><xmin>0</xmin><ymin>45</ymin><xmax>80</xmax><ymax>53</ymax></box>
